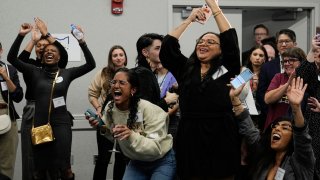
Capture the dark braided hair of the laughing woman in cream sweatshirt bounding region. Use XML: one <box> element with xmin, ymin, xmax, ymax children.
<box><xmin>108</xmin><ymin>68</ymin><xmax>140</xmax><ymax>129</ymax></box>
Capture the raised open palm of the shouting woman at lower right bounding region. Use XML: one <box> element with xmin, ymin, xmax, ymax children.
<box><xmin>287</xmin><ymin>77</ymin><xmax>308</xmax><ymax>106</ymax></box>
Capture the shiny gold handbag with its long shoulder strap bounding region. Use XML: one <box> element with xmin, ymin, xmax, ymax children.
<box><xmin>31</xmin><ymin>71</ymin><xmax>59</xmax><ymax>145</ymax></box>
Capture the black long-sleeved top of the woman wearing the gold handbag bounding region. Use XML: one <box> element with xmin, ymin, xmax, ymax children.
<box><xmin>8</xmin><ymin>36</ymin><xmax>96</xmax><ymax>126</ymax></box>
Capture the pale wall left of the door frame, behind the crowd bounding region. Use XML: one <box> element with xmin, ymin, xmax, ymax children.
<box><xmin>0</xmin><ymin>0</ymin><xmax>167</xmax><ymax>115</ymax></box>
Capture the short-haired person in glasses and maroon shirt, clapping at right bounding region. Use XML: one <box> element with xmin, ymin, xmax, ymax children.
<box><xmin>264</xmin><ymin>47</ymin><xmax>307</xmax><ymax>129</ymax></box>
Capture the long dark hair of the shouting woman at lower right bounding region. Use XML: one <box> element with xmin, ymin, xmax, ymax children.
<box><xmin>249</xmin><ymin>116</ymin><xmax>294</xmax><ymax>177</ymax></box>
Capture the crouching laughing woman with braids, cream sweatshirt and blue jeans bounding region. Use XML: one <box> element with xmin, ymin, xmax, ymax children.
<box><xmin>89</xmin><ymin>68</ymin><xmax>176</xmax><ymax>180</ymax></box>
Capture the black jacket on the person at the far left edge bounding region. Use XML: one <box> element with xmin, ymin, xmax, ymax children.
<box><xmin>0</xmin><ymin>61</ymin><xmax>23</xmax><ymax>121</ymax></box>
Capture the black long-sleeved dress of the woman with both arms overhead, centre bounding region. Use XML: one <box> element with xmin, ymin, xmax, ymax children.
<box><xmin>160</xmin><ymin>29</ymin><xmax>240</xmax><ymax>179</ymax></box>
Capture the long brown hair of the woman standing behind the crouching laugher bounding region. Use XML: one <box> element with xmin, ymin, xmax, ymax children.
<box><xmin>101</xmin><ymin>45</ymin><xmax>127</xmax><ymax>93</ymax></box>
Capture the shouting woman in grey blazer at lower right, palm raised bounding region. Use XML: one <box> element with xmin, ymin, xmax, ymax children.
<box><xmin>230</xmin><ymin>77</ymin><xmax>315</xmax><ymax>180</ymax></box>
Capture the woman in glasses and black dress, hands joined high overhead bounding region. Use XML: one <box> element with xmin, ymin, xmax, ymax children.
<box><xmin>160</xmin><ymin>0</ymin><xmax>240</xmax><ymax>180</ymax></box>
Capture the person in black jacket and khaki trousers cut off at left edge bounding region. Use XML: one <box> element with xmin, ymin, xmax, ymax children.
<box><xmin>0</xmin><ymin>42</ymin><xmax>23</xmax><ymax>180</ymax></box>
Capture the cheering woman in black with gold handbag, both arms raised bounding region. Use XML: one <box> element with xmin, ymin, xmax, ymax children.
<box><xmin>8</xmin><ymin>19</ymin><xmax>96</xmax><ymax>180</ymax></box>
